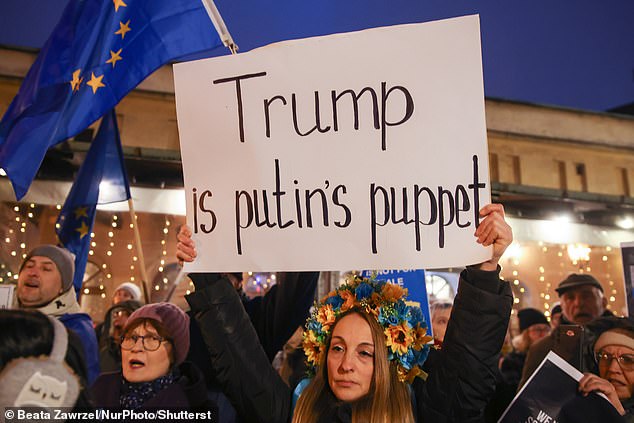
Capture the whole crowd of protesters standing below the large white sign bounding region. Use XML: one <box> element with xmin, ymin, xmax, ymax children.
<box><xmin>0</xmin><ymin>204</ymin><xmax>634</xmax><ymax>423</ymax></box>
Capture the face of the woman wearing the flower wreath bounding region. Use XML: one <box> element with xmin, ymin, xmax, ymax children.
<box><xmin>327</xmin><ymin>313</ymin><xmax>374</xmax><ymax>401</ymax></box>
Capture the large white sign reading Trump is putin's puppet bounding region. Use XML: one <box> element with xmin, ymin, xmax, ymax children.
<box><xmin>174</xmin><ymin>16</ymin><xmax>491</xmax><ymax>271</ymax></box>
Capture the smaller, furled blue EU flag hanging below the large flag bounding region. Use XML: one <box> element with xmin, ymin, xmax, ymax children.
<box><xmin>55</xmin><ymin>110</ymin><xmax>130</xmax><ymax>294</ymax></box>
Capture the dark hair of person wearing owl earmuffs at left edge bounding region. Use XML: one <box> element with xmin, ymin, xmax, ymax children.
<box><xmin>0</xmin><ymin>310</ymin><xmax>54</xmax><ymax>369</ymax></box>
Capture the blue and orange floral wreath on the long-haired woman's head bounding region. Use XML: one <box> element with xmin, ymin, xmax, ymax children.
<box><xmin>303</xmin><ymin>276</ymin><xmax>432</xmax><ymax>383</ymax></box>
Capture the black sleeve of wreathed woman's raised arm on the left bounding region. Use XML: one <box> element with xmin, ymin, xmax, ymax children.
<box><xmin>186</xmin><ymin>273</ymin><xmax>291</xmax><ymax>423</ymax></box>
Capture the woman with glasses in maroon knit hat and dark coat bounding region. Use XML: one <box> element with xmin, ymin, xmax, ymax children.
<box><xmin>91</xmin><ymin>303</ymin><xmax>215</xmax><ymax>411</ymax></box>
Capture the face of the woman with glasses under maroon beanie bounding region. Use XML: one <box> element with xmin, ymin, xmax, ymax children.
<box><xmin>121</xmin><ymin>325</ymin><xmax>170</xmax><ymax>383</ymax></box>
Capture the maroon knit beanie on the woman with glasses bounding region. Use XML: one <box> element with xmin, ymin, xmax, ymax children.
<box><xmin>123</xmin><ymin>303</ymin><xmax>189</xmax><ymax>365</ymax></box>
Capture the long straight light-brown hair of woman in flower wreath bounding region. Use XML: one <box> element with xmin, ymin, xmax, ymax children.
<box><xmin>293</xmin><ymin>308</ymin><xmax>414</xmax><ymax>423</ymax></box>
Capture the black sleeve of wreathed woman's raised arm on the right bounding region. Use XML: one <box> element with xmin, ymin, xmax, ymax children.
<box><xmin>413</xmin><ymin>267</ymin><xmax>513</xmax><ymax>422</ymax></box>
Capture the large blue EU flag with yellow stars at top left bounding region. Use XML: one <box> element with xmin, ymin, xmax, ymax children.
<box><xmin>0</xmin><ymin>0</ymin><xmax>221</xmax><ymax>199</ymax></box>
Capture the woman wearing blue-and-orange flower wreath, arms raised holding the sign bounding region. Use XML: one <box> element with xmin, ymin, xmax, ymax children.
<box><xmin>177</xmin><ymin>204</ymin><xmax>513</xmax><ymax>423</ymax></box>
